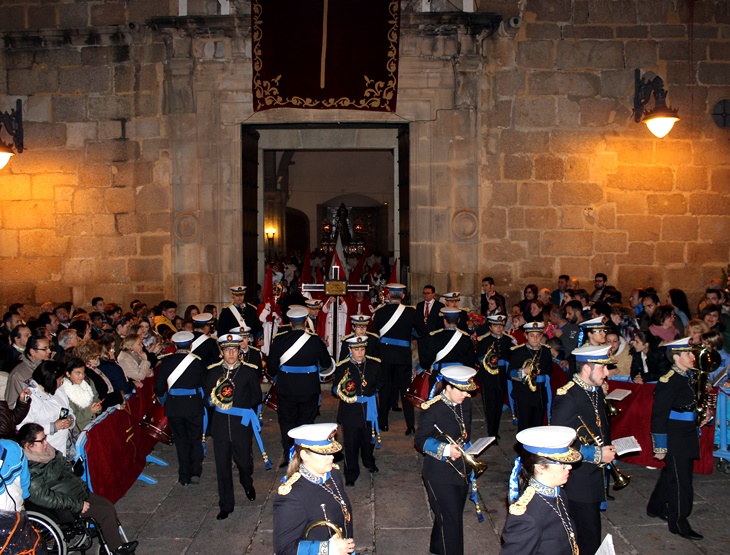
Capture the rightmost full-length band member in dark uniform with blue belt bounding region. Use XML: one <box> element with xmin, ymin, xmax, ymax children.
<box><xmin>646</xmin><ymin>337</ymin><xmax>710</xmax><ymax>540</ymax></box>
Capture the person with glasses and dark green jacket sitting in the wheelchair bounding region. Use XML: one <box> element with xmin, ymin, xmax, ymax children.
<box><xmin>18</xmin><ymin>423</ymin><xmax>138</xmax><ymax>555</ymax></box>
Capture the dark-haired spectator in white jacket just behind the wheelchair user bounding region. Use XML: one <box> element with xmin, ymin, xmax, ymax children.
<box><xmin>18</xmin><ymin>360</ymin><xmax>75</xmax><ymax>458</ymax></box>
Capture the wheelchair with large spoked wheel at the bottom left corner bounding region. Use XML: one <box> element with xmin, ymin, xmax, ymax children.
<box><xmin>25</xmin><ymin>500</ymin><xmax>128</xmax><ymax>555</ymax></box>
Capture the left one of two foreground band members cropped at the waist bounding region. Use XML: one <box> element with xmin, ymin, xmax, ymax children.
<box><xmin>274</xmin><ymin>423</ymin><xmax>355</xmax><ymax>555</ymax></box>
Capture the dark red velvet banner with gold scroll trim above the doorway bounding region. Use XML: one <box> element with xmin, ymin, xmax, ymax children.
<box><xmin>251</xmin><ymin>0</ymin><xmax>400</xmax><ymax>112</ymax></box>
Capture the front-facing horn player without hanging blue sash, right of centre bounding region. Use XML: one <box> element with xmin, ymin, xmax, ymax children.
<box><xmin>477</xmin><ymin>314</ymin><xmax>514</xmax><ymax>439</ymax></box>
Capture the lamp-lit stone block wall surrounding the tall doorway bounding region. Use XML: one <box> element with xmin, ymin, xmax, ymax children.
<box><xmin>0</xmin><ymin>0</ymin><xmax>730</xmax><ymax>312</ymax></box>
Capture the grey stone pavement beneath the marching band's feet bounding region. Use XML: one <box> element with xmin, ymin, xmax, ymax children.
<box><xmin>109</xmin><ymin>392</ymin><xmax>730</xmax><ymax>555</ymax></box>
